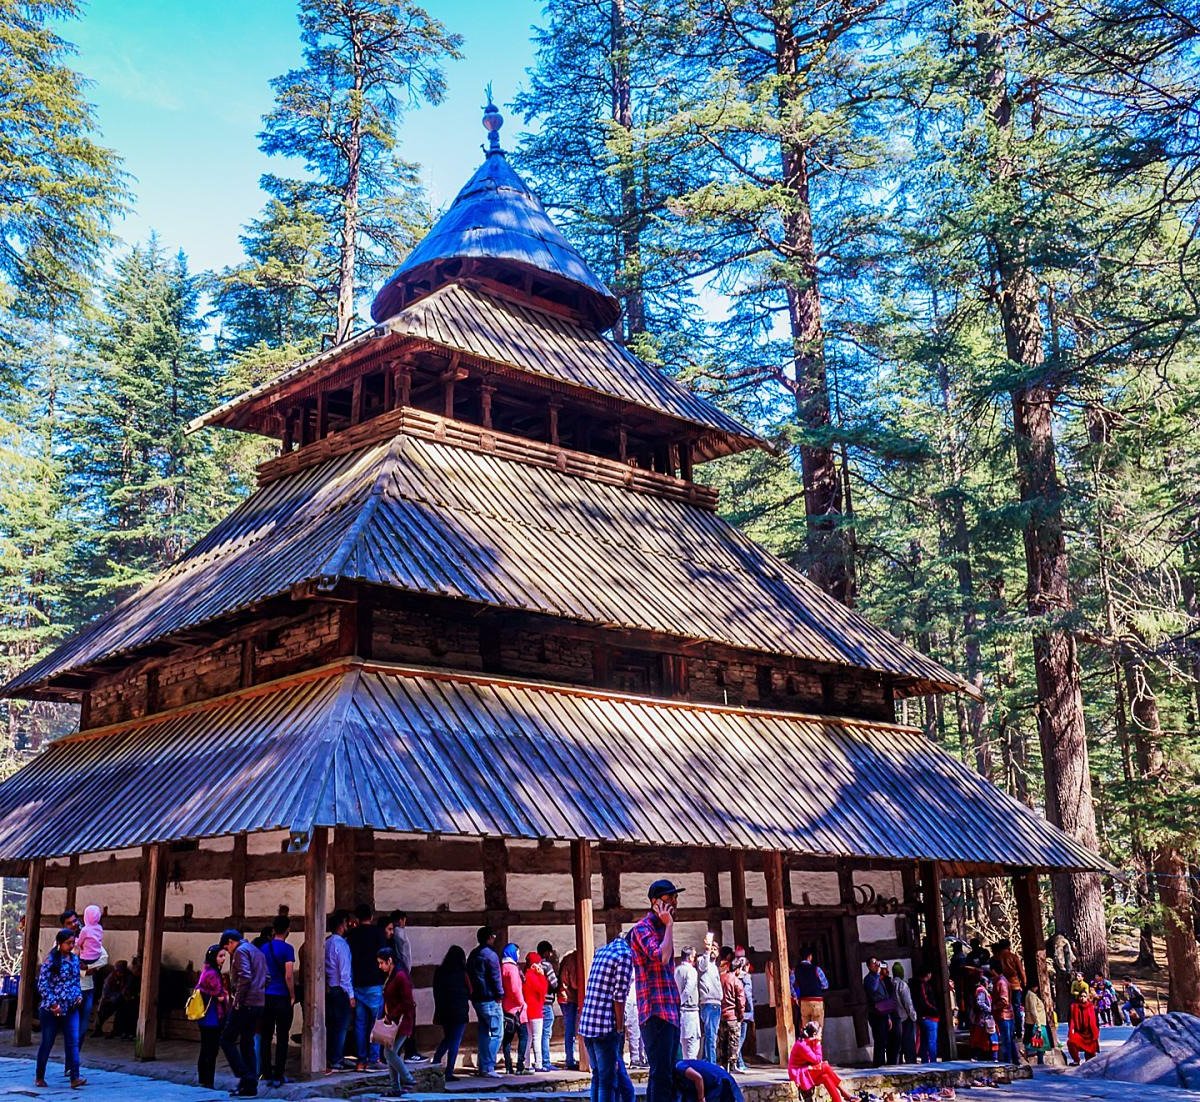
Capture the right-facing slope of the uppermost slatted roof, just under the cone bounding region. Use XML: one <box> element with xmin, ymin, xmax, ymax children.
<box><xmin>388</xmin><ymin>283</ymin><xmax>766</xmax><ymax>454</ymax></box>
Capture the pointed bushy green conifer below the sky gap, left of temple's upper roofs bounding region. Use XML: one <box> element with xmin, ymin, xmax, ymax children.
<box><xmin>67</xmin><ymin>239</ymin><xmax>228</xmax><ymax>612</ymax></box>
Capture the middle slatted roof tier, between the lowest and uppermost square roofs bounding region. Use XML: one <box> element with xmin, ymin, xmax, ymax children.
<box><xmin>6</xmin><ymin>432</ymin><xmax>967</xmax><ymax>693</ymax></box>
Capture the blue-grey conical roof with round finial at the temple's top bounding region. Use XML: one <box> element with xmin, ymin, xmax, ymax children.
<box><xmin>371</xmin><ymin>104</ymin><xmax>620</xmax><ymax>329</ymax></box>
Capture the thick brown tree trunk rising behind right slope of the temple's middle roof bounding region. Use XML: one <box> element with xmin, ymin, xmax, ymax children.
<box><xmin>774</xmin><ymin>12</ymin><xmax>856</xmax><ymax>605</ymax></box>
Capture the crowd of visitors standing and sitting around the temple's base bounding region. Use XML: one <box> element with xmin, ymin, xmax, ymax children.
<box><xmin>25</xmin><ymin>880</ymin><xmax>1146</xmax><ymax>1102</ymax></box>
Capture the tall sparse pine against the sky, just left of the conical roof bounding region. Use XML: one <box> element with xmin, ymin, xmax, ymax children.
<box><xmin>259</xmin><ymin>0</ymin><xmax>462</xmax><ymax>341</ymax></box>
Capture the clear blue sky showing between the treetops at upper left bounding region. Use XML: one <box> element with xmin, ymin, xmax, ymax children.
<box><xmin>64</xmin><ymin>0</ymin><xmax>541</xmax><ymax>270</ymax></box>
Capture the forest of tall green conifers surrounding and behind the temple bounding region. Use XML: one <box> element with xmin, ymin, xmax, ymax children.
<box><xmin>0</xmin><ymin>0</ymin><xmax>1200</xmax><ymax>1012</ymax></box>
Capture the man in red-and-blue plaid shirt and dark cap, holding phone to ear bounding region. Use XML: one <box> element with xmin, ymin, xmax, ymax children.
<box><xmin>629</xmin><ymin>880</ymin><xmax>680</xmax><ymax>1102</ymax></box>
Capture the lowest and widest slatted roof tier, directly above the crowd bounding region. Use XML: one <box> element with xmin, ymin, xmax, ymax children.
<box><xmin>0</xmin><ymin>661</ymin><xmax>1105</xmax><ymax>868</ymax></box>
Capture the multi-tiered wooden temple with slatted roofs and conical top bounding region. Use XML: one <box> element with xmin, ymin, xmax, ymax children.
<box><xmin>0</xmin><ymin>108</ymin><xmax>1102</xmax><ymax>1072</ymax></box>
